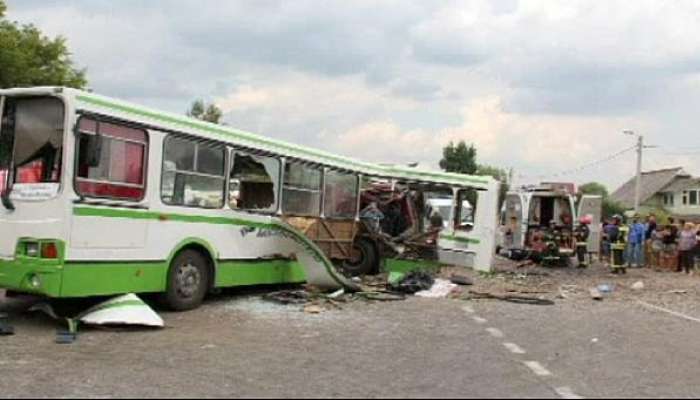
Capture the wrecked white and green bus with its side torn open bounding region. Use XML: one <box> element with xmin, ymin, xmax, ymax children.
<box><xmin>0</xmin><ymin>87</ymin><xmax>498</xmax><ymax>310</ymax></box>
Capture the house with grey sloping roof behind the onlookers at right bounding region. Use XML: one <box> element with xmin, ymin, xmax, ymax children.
<box><xmin>610</xmin><ymin>168</ymin><xmax>700</xmax><ymax>222</ymax></box>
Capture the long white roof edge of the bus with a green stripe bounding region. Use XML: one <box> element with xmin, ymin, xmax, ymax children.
<box><xmin>0</xmin><ymin>87</ymin><xmax>495</xmax><ymax>189</ymax></box>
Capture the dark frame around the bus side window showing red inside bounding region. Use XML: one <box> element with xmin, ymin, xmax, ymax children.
<box><xmin>73</xmin><ymin>113</ymin><xmax>151</xmax><ymax>203</ymax></box>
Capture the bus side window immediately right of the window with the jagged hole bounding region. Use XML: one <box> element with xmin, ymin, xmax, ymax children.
<box><xmin>282</xmin><ymin>162</ymin><xmax>321</xmax><ymax>217</ymax></box>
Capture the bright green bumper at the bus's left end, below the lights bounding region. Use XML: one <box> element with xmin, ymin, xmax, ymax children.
<box><xmin>0</xmin><ymin>256</ymin><xmax>63</xmax><ymax>297</ymax></box>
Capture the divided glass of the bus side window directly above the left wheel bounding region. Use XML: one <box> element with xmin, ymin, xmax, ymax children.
<box><xmin>161</xmin><ymin>137</ymin><xmax>226</xmax><ymax>208</ymax></box>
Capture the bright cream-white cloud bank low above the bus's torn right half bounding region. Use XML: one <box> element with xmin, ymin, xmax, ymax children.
<box><xmin>336</xmin><ymin>97</ymin><xmax>652</xmax><ymax>189</ymax></box>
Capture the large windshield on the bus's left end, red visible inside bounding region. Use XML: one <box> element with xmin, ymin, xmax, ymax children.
<box><xmin>0</xmin><ymin>97</ymin><xmax>64</xmax><ymax>196</ymax></box>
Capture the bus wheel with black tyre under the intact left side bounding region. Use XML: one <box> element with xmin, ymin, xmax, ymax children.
<box><xmin>163</xmin><ymin>250</ymin><xmax>209</xmax><ymax>311</ymax></box>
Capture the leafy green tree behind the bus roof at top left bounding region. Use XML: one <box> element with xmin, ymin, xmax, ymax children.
<box><xmin>0</xmin><ymin>0</ymin><xmax>87</xmax><ymax>89</ymax></box>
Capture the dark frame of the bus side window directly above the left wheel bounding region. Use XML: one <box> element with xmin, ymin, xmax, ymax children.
<box><xmin>158</xmin><ymin>131</ymin><xmax>229</xmax><ymax>210</ymax></box>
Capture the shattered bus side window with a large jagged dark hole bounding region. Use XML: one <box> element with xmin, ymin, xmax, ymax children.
<box><xmin>229</xmin><ymin>151</ymin><xmax>280</xmax><ymax>212</ymax></box>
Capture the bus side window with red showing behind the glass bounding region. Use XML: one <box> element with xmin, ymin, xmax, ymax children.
<box><xmin>76</xmin><ymin>118</ymin><xmax>148</xmax><ymax>201</ymax></box>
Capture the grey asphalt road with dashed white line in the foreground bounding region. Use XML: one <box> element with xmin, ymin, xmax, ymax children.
<box><xmin>0</xmin><ymin>293</ymin><xmax>700</xmax><ymax>398</ymax></box>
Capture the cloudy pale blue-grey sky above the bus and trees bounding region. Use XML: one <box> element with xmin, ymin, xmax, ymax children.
<box><xmin>7</xmin><ymin>0</ymin><xmax>700</xmax><ymax>190</ymax></box>
